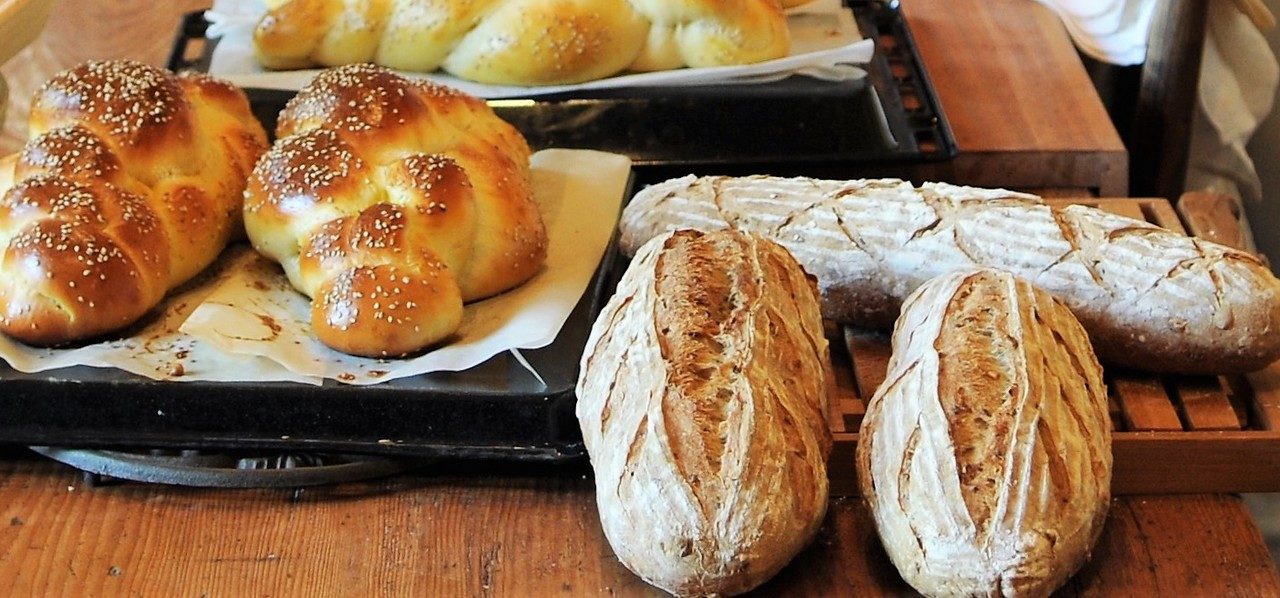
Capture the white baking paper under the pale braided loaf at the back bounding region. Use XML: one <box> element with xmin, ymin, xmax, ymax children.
<box><xmin>205</xmin><ymin>0</ymin><xmax>874</xmax><ymax>99</ymax></box>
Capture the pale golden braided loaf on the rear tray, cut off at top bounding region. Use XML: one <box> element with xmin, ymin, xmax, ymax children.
<box><xmin>253</xmin><ymin>0</ymin><xmax>808</xmax><ymax>85</ymax></box>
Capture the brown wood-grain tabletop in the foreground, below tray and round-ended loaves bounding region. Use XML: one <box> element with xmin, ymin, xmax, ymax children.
<box><xmin>0</xmin><ymin>457</ymin><xmax>1280</xmax><ymax>597</ymax></box>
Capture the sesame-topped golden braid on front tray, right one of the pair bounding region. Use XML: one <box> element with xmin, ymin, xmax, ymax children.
<box><xmin>244</xmin><ymin>64</ymin><xmax>547</xmax><ymax>356</ymax></box>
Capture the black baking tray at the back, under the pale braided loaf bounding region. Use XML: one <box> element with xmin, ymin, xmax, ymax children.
<box><xmin>168</xmin><ymin>0</ymin><xmax>956</xmax><ymax>172</ymax></box>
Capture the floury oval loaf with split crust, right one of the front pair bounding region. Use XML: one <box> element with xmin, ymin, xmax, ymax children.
<box><xmin>856</xmin><ymin>270</ymin><xmax>1111</xmax><ymax>595</ymax></box>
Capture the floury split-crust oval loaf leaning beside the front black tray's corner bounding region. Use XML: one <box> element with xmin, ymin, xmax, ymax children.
<box><xmin>577</xmin><ymin>230</ymin><xmax>832</xmax><ymax>595</ymax></box>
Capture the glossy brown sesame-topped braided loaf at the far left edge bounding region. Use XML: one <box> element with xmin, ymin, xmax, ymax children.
<box><xmin>0</xmin><ymin>61</ymin><xmax>266</xmax><ymax>346</ymax></box>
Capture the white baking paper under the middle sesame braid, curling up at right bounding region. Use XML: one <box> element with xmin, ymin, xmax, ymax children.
<box><xmin>182</xmin><ymin>150</ymin><xmax>631</xmax><ymax>384</ymax></box>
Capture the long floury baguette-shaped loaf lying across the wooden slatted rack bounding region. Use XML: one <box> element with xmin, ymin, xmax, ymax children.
<box><xmin>621</xmin><ymin>177</ymin><xmax>1280</xmax><ymax>374</ymax></box>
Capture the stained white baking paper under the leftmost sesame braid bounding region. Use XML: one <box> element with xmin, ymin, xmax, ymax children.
<box><xmin>0</xmin><ymin>245</ymin><xmax>320</xmax><ymax>384</ymax></box>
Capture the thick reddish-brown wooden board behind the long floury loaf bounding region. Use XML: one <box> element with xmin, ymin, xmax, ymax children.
<box><xmin>902</xmin><ymin>0</ymin><xmax>1129</xmax><ymax>196</ymax></box>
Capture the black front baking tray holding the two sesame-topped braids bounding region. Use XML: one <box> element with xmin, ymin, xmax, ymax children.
<box><xmin>0</xmin><ymin>229</ymin><xmax>618</xmax><ymax>462</ymax></box>
